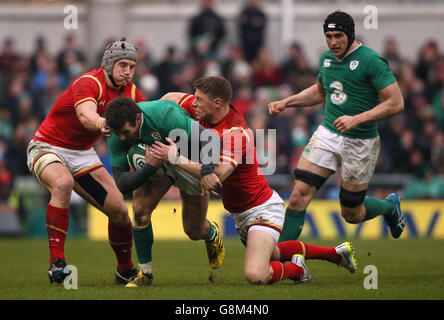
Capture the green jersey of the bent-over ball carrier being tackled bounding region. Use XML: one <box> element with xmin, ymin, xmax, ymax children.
<box><xmin>108</xmin><ymin>100</ymin><xmax>195</xmax><ymax>169</ymax></box>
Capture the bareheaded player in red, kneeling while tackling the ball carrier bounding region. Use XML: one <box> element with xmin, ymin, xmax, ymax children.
<box><xmin>151</xmin><ymin>77</ymin><xmax>357</xmax><ymax>284</ymax></box>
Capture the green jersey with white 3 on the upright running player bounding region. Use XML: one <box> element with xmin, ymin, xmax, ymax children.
<box><xmin>317</xmin><ymin>45</ymin><xmax>396</xmax><ymax>139</ymax></box>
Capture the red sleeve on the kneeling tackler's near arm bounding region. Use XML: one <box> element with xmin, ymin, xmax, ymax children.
<box><xmin>220</xmin><ymin>127</ymin><xmax>254</xmax><ymax>168</ymax></box>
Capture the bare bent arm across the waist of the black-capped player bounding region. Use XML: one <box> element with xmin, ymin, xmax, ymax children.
<box><xmin>333</xmin><ymin>82</ymin><xmax>404</xmax><ymax>133</ymax></box>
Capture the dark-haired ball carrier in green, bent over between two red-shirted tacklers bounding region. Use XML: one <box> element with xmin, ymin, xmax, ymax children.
<box><xmin>104</xmin><ymin>97</ymin><xmax>225</xmax><ymax>287</ymax></box>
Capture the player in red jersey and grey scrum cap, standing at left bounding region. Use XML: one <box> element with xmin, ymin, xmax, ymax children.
<box><xmin>27</xmin><ymin>38</ymin><xmax>145</xmax><ymax>283</ymax></box>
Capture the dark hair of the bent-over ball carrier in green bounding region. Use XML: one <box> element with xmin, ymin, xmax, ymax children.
<box><xmin>103</xmin><ymin>97</ymin><xmax>140</xmax><ymax>130</ymax></box>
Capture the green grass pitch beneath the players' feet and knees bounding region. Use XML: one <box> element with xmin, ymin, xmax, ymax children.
<box><xmin>0</xmin><ymin>238</ymin><xmax>444</xmax><ymax>300</ymax></box>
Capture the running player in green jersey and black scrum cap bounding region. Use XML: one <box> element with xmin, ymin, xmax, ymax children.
<box><xmin>268</xmin><ymin>11</ymin><xmax>405</xmax><ymax>241</ymax></box>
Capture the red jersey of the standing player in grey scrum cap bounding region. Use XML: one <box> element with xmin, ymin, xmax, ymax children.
<box><xmin>34</xmin><ymin>68</ymin><xmax>146</xmax><ymax>150</ymax></box>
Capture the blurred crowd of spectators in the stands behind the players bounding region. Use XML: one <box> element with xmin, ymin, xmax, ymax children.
<box><xmin>0</xmin><ymin>0</ymin><xmax>444</xmax><ymax>205</ymax></box>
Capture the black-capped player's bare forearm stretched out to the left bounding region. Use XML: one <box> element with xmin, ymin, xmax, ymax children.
<box><xmin>268</xmin><ymin>82</ymin><xmax>325</xmax><ymax>116</ymax></box>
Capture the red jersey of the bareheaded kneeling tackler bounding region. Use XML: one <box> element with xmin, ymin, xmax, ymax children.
<box><xmin>179</xmin><ymin>94</ymin><xmax>273</xmax><ymax>213</ymax></box>
